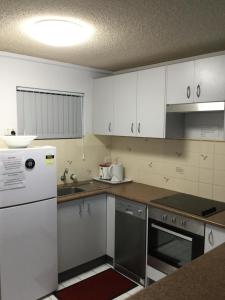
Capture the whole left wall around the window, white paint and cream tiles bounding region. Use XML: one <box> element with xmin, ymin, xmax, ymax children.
<box><xmin>0</xmin><ymin>52</ymin><xmax>109</xmax><ymax>182</ymax></box>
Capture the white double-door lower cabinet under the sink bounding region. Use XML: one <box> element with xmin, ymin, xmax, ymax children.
<box><xmin>58</xmin><ymin>195</ymin><xmax>106</xmax><ymax>273</ymax></box>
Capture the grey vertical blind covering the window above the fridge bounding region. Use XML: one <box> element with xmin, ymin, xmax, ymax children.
<box><xmin>17</xmin><ymin>87</ymin><xmax>84</xmax><ymax>139</ymax></box>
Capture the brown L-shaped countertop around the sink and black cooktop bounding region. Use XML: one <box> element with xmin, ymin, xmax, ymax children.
<box><xmin>58</xmin><ymin>181</ymin><xmax>225</xmax><ymax>228</ymax></box>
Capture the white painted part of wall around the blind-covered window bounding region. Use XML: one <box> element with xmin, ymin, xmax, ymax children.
<box><xmin>0</xmin><ymin>52</ymin><xmax>110</xmax><ymax>135</ymax></box>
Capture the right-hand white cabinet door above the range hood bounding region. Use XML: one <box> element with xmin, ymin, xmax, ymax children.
<box><xmin>194</xmin><ymin>55</ymin><xmax>225</xmax><ymax>102</ymax></box>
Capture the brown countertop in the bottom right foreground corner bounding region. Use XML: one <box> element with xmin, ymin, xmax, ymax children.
<box><xmin>129</xmin><ymin>244</ymin><xmax>225</xmax><ymax>300</ymax></box>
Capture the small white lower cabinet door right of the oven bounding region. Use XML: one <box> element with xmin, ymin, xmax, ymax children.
<box><xmin>204</xmin><ymin>224</ymin><xmax>225</xmax><ymax>253</ymax></box>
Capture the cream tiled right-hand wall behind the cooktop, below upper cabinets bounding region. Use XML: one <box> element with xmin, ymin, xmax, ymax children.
<box><xmin>111</xmin><ymin>137</ymin><xmax>225</xmax><ymax>202</ymax></box>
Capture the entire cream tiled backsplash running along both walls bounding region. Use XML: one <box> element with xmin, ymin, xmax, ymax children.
<box><xmin>0</xmin><ymin>134</ymin><xmax>225</xmax><ymax>202</ymax></box>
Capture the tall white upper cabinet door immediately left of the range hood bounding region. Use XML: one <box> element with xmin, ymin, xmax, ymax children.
<box><xmin>137</xmin><ymin>67</ymin><xmax>165</xmax><ymax>138</ymax></box>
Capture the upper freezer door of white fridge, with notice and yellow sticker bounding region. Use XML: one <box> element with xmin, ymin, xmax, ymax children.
<box><xmin>0</xmin><ymin>147</ymin><xmax>57</xmax><ymax>207</ymax></box>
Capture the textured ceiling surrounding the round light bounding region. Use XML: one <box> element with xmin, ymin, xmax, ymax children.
<box><xmin>0</xmin><ymin>0</ymin><xmax>225</xmax><ymax>71</ymax></box>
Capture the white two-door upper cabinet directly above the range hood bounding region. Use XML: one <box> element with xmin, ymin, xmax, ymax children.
<box><xmin>166</xmin><ymin>55</ymin><xmax>225</xmax><ymax>104</ymax></box>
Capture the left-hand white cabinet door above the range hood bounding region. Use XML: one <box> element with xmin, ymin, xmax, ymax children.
<box><xmin>166</xmin><ymin>61</ymin><xmax>194</xmax><ymax>104</ymax></box>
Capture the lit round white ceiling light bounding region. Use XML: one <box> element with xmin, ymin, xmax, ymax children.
<box><xmin>24</xmin><ymin>19</ymin><xmax>94</xmax><ymax>47</ymax></box>
